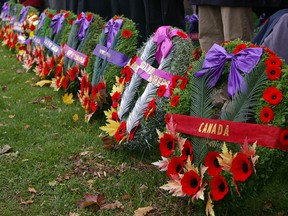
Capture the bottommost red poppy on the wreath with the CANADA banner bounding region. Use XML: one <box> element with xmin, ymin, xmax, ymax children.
<box><xmin>210</xmin><ymin>175</ymin><xmax>229</xmax><ymax>201</ymax></box>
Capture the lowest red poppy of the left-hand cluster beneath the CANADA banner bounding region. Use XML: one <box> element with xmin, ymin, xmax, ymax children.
<box><xmin>181</xmin><ymin>170</ymin><xmax>201</xmax><ymax>196</ymax></box>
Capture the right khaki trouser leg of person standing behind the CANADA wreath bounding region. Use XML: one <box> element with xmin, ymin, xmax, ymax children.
<box><xmin>221</xmin><ymin>7</ymin><xmax>253</xmax><ymax>41</ymax></box>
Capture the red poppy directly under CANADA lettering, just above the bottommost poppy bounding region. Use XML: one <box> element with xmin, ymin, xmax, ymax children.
<box><xmin>204</xmin><ymin>151</ymin><xmax>222</xmax><ymax>176</ymax></box>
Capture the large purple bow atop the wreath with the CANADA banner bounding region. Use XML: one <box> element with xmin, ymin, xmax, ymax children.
<box><xmin>194</xmin><ymin>44</ymin><xmax>263</xmax><ymax>97</ymax></box>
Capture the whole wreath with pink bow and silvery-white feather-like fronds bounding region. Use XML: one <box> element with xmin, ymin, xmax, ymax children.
<box><xmin>101</xmin><ymin>26</ymin><xmax>192</xmax><ymax>150</ymax></box>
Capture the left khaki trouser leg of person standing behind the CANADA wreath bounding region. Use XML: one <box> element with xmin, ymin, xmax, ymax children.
<box><xmin>199</xmin><ymin>6</ymin><xmax>224</xmax><ymax>52</ymax></box>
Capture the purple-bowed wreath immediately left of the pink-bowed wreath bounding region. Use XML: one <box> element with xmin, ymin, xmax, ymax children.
<box><xmin>78</xmin><ymin>16</ymin><xmax>138</xmax><ymax>122</ymax></box>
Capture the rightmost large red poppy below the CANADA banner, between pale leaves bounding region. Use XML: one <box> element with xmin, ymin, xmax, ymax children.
<box><xmin>230</xmin><ymin>153</ymin><xmax>252</xmax><ymax>182</ymax></box>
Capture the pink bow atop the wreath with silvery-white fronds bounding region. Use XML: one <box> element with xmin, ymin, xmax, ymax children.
<box><xmin>153</xmin><ymin>26</ymin><xmax>178</xmax><ymax>64</ymax></box>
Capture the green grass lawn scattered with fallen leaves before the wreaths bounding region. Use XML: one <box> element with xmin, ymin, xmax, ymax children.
<box><xmin>0</xmin><ymin>47</ymin><xmax>288</xmax><ymax>216</ymax></box>
